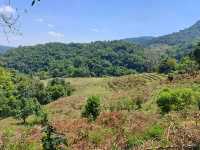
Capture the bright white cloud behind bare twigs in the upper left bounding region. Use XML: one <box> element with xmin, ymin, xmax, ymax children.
<box><xmin>0</xmin><ymin>5</ymin><xmax>16</xmax><ymax>18</ymax></box>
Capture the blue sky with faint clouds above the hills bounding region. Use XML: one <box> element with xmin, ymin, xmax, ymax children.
<box><xmin>0</xmin><ymin>0</ymin><xmax>200</xmax><ymax>46</ymax></box>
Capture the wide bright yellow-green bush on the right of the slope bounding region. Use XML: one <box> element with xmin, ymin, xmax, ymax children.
<box><xmin>157</xmin><ymin>88</ymin><xmax>194</xmax><ymax>114</ymax></box>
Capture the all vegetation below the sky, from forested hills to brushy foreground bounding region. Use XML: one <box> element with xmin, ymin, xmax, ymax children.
<box><xmin>0</xmin><ymin>18</ymin><xmax>200</xmax><ymax>150</ymax></box>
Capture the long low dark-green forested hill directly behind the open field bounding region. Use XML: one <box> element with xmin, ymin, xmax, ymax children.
<box><xmin>2</xmin><ymin>41</ymin><xmax>152</xmax><ymax>78</ymax></box>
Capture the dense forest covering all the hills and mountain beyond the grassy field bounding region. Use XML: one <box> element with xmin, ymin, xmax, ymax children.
<box><xmin>0</xmin><ymin>22</ymin><xmax>200</xmax><ymax>79</ymax></box>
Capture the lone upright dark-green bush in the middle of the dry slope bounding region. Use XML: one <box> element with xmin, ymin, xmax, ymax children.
<box><xmin>82</xmin><ymin>96</ymin><xmax>101</xmax><ymax>120</ymax></box>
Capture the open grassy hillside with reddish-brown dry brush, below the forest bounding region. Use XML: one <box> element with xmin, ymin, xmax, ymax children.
<box><xmin>0</xmin><ymin>74</ymin><xmax>200</xmax><ymax>150</ymax></box>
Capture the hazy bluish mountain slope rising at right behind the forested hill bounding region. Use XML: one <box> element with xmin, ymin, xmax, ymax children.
<box><xmin>124</xmin><ymin>21</ymin><xmax>200</xmax><ymax>59</ymax></box>
